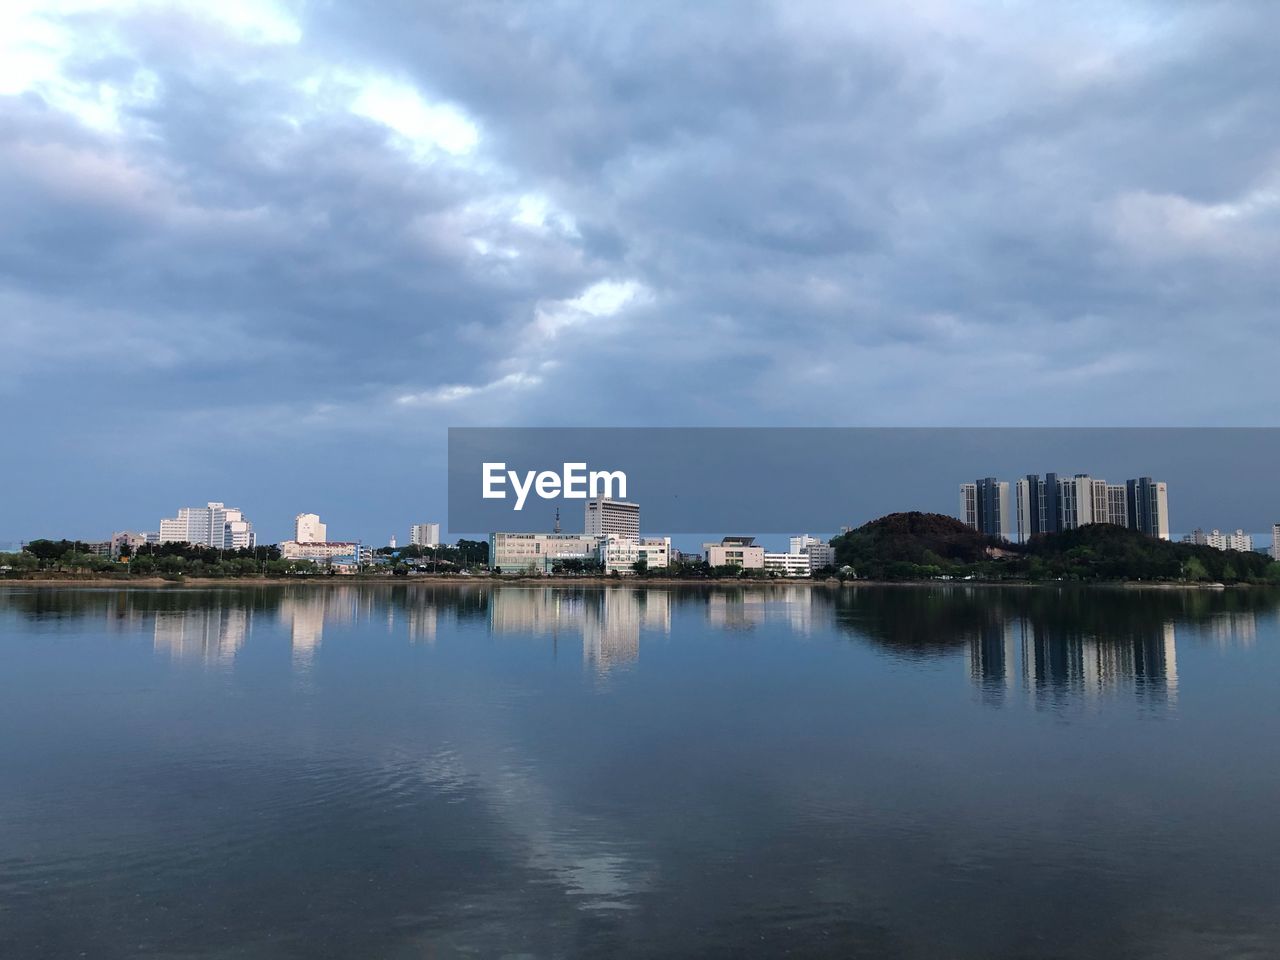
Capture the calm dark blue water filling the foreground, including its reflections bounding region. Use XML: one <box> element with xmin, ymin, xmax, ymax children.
<box><xmin>0</xmin><ymin>585</ymin><xmax>1280</xmax><ymax>960</ymax></box>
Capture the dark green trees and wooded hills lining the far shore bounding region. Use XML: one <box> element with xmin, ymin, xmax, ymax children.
<box><xmin>0</xmin><ymin>512</ymin><xmax>1280</xmax><ymax>589</ymax></box>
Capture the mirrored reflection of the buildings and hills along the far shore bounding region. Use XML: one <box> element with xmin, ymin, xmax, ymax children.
<box><xmin>0</xmin><ymin>584</ymin><xmax>1276</xmax><ymax>707</ymax></box>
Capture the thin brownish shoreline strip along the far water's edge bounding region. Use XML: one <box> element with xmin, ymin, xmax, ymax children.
<box><xmin>0</xmin><ymin>573</ymin><xmax>1249</xmax><ymax>591</ymax></box>
